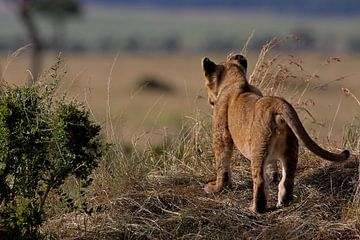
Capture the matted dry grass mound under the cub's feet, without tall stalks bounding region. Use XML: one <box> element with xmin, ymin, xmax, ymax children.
<box><xmin>43</xmin><ymin>124</ymin><xmax>360</xmax><ymax>239</ymax></box>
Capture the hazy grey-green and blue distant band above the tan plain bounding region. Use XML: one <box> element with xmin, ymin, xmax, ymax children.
<box><xmin>0</xmin><ymin>0</ymin><xmax>360</xmax><ymax>53</ymax></box>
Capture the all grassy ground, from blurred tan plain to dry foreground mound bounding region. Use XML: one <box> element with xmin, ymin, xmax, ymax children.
<box><xmin>0</xmin><ymin>46</ymin><xmax>360</xmax><ymax>239</ymax></box>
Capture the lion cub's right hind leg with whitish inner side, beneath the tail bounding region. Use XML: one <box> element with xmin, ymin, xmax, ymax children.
<box><xmin>276</xmin><ymin>131</ymin><xmax>299</xmax><ymax>207</ymax></box>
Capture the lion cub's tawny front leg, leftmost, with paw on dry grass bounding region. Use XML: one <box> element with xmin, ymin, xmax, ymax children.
<box><xmin>204</xmin><ymin>124</ymin><xmax>234</xmax><ymax>193</ymax></box>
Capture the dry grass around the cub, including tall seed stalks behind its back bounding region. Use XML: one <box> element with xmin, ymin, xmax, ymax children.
<box><xmin>0</xmin><ymin>40</ymin><xmax>360</xmax><ymax>239</ymax></box>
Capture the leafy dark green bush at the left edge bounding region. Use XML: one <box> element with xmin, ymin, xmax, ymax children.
<box><xmin>0</xmin><ymin>63</ymin><xmax>103</xmax><ymax>239</ymax></box>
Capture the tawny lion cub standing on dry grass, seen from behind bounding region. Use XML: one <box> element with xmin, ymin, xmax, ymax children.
<box><xmin>202</xmin><ymin>54</ymin><xmax>350</xmax><ymax>213</ymax></box>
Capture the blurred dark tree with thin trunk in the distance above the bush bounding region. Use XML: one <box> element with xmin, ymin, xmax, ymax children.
<box><xmin>8</xmin><ymin>0</ymin><xmax>80</xmax><ymax>84</ymax></box>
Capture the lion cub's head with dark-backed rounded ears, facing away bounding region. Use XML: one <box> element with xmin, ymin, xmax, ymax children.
<box><xmin>202</xmin><ymin>54</ymin><xmax>247</xmax><ymax>106</ymax></box>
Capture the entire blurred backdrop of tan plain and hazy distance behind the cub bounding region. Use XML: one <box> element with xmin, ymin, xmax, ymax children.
<box><xmin>0</xmin><ymin>0</ymin><xmax>360</xmax><ymax>146</ymax></box>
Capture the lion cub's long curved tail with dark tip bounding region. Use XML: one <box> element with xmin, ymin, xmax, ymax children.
<box><xmin>278</xmin><ymin>100</ymin><xmax>350</xmax><ymax>162</ymax></box>
